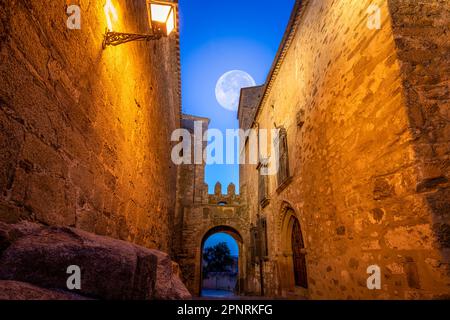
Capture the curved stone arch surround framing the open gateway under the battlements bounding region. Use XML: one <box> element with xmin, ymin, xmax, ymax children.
<box><xmin>196</xmin><ymin>225</ymin><xmax>245</xmax><ymax>295</ymax></box>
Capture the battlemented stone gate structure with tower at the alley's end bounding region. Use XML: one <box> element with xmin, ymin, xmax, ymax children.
<box><xmin>174</xmin><ymin>115</ymin><xmax>250</xmax><ymax>295</ymax></box>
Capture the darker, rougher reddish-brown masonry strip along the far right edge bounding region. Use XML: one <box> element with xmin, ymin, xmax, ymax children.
<box><xmin>389</xmin><ymin>0</ymin><xmax>450</xmax><ymax>259</ymax></box>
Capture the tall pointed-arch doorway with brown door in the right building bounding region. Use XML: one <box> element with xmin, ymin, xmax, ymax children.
<box><xmin>279</xmin><ymin>208</ymin><xmax>308</xmax><ymax>295</ymax></box>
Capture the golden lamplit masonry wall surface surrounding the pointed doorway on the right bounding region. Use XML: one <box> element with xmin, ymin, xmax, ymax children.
<box><xmin>246</xmin><ymin>0</ymin><xmax>450</xmax><ymax>299</ymax></box>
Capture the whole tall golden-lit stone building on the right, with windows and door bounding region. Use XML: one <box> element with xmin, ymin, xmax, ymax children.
<box><xmin>239</xmin><ymin>0</ymin><xmax>450</xmax><ymax>299</ymax></box>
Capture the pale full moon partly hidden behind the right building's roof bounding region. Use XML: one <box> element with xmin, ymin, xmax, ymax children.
<box><xmin>216</xmin><ymin>70</ymin><xmax>256</xmax><ymax>111</ymax></box>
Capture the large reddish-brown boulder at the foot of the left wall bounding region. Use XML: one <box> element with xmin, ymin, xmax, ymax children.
<box><xmin>0</xmin><ymin>222</ymin><xmax>191</xmax><ymax>300</ymax></box>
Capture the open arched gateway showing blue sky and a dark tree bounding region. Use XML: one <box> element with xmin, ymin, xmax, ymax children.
<box><xmin>199</xmin><ymin>226</ymin><xmax>243</xmax><ymax>298</ymax></box>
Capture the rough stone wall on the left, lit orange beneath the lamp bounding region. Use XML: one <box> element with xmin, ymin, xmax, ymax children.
<box><xmin>0</xmin><ymin>0</ymin><xmax>180</xmax><ymax>251</ymax></box>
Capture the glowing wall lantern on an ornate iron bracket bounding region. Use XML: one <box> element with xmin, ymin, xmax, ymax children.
<box><xmin>103</xmin><ymin>0</ymin><xmax>177</xmax><ymax>49</ymax></box>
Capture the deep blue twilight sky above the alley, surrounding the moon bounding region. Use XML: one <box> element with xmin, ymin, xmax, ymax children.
<box><xmin>179</xmin><ymin>0</ymin><xmax>295</xmax><ymax>193</ymax></box>
